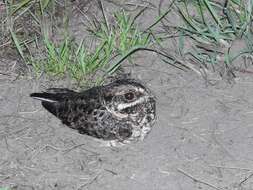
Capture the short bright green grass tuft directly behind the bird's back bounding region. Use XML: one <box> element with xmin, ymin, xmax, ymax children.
<box><xmin>30</xmin><ymin>34</ymin><xmax>114</xmax><ymax>83</ymax></box>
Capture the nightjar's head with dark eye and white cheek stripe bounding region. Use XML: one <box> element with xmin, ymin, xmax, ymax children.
<box><xmin>103</xmin><ymin>79</ymin><xmax>155</xmax><ymax>122</ymax></box>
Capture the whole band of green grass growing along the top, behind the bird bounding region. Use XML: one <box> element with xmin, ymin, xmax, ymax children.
<box><xmin>1</xmin><ymin>0</ymin><xmax>253</xmax><ymax>84</ymax></box>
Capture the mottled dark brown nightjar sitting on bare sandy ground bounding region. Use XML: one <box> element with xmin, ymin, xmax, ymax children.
<box><xmin>30</xmin><ymin>79</ymin><xmax>156</xmax><ymax>143</ymax></box>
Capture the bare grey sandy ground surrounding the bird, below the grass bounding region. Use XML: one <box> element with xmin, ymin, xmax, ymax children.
<box><xmin>0</xmin><ymin>0</ymin><xmax>253</xmax><ymax>190</ymax></box>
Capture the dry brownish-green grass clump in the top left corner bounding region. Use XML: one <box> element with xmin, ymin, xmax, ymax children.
<box><xmin>3</xmin><ymin>0</ymin><xmax>54</xmax><ymax>69</ymax></box>
